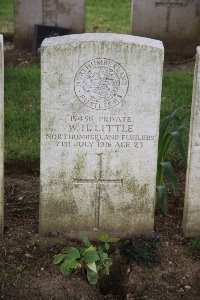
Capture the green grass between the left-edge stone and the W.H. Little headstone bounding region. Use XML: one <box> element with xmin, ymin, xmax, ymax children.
<box><xmin>5</xmin><ymin>65</ymin><xmax>40</xmax><ymax>161</ymax></box>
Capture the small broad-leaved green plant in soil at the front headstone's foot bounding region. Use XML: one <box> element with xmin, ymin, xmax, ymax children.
<box><xmin>53</xmin><ymin>232</ymin><xmax>119</xmax><ymax>284</ymax></box>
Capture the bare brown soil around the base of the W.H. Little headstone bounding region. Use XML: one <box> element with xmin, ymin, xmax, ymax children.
<box><xmin>0</xmin><ymin>163</ymin><xmax>200</xmax><ymax>300</ymax></box>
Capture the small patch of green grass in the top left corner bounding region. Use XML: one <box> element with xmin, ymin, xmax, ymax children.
<box><xmin>0</xmin><ymin>0</ymin><xmax>14</xmax><ymax>33</ymax></box>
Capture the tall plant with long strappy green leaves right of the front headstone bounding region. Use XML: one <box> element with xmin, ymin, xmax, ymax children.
<box><xmin>156</xmin><ymin>111</ymin><xmax>186</xmax><ymax>214</ymax></box>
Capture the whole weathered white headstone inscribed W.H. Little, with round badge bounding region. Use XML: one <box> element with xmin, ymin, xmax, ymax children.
<box><xmin>40</xmin><ymin>34</ymin><xmax>164</xmax><ymax>238</ymax></box>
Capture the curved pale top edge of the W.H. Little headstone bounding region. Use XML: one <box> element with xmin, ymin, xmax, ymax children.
<box><xmin>41</xmin><ymin>33</ymin><xmax>164</xmax><ymax>51</ymax></box>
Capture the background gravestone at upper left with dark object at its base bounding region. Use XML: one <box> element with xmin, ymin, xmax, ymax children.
<box><xmin>14</xmin><ymin>0</ymin><xmax>85</xmax><ymax>49</ymax></box>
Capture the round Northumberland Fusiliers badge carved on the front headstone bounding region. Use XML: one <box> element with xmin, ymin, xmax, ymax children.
<box><xmin>74</xmin><ymin>58</ymin><xmax>128</xmax><ymax>110</ymax></box>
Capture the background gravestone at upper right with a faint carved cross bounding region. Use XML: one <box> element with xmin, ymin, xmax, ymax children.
<box><xmin>132</xmin><ymin>0</ymin><xmax>200</xmax><ymax>56</ymax></box>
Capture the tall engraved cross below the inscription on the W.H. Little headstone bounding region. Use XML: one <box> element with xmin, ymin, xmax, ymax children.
<box><xmin>74</xmin><ymin>153</ymin><xmax>123</xmax><ymax>228</ymax></box>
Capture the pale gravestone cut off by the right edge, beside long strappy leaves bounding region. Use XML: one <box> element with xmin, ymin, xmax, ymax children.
<box><xmin>183</xmin><ymin>47</ymin><xmax>200</xmax><ymax>236</ymax></box>
